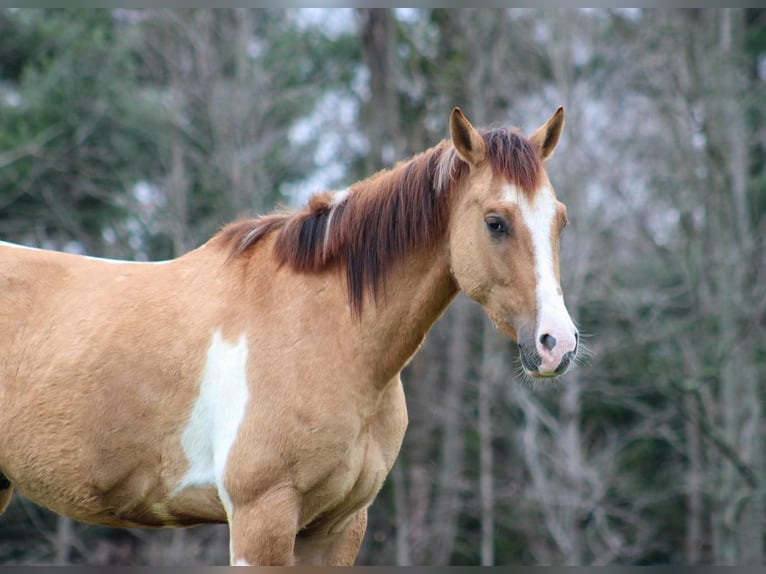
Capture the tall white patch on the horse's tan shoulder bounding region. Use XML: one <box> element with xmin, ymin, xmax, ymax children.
<box><xmin>174</xmin><ymin>331</ymin><xmax>248</xmax><ymax>516</ymax></box>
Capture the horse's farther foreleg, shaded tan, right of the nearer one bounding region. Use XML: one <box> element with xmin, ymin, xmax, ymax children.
<box><xmin>295</xmin><ymin>508</ymin><xmax>367</xmax><ymax>566</ymax></box>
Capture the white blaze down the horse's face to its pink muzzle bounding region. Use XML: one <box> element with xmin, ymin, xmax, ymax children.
<box><xmin>505</xmin><ymin>186</ymin><xmax>577</xmax><ymax>374</ymax></box>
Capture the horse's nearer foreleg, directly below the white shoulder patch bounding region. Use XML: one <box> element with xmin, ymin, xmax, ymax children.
<box><xmin>229</xmin><ymin>489</ymin><xmax>298</xmax><ymax>566</ymax></box>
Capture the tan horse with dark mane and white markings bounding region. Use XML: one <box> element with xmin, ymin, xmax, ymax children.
<box><xmin>0</xmin><ymin>107</ymin><xmax>578</xmax><ymax>565</ymax></box>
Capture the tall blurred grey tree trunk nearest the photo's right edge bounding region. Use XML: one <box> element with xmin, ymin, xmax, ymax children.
<box><xmin>699</xmin><ymin>9</ymin><xmax>764</xmax><ymax>565</ymax></box>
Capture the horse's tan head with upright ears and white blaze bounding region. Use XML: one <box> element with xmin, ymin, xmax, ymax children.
<box><xmin>449</xmin><ymin>108</ymin><xmax>578</xmax><ymax>377</ymax></box>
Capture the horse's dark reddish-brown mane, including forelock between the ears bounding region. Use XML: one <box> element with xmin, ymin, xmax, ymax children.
<box><xmin>216</xmin><ymin>128</ymin><xmax>542</xmax><ymax>314</ymax></box>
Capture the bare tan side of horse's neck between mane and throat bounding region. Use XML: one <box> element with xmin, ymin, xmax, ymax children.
<box><xmin>360</xmin><ymin>245</ymin><xmax>458</xmax><ymax>384</ymax></box>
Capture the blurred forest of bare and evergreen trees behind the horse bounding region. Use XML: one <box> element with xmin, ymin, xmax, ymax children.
<box><xmin>0</xmin><ymin>9</ymin><xmax>766</xmax><ymax>565</ymax></box>
